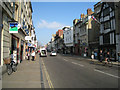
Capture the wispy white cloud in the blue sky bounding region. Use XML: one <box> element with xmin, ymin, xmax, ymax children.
<box><xmin>38</xmin><ymin>20</ymin><xmax>64</xmax><ymax>29</ymax></box>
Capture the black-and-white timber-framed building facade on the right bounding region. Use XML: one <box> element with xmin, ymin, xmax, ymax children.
<box><xmin>99</xmin><ymin>2</ymin><xmax>119</xmax><ymax>60</ymax></box>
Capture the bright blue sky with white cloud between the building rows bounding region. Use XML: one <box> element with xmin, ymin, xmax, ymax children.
<box><xmin>32</xmin><ymin>2</ymin><xmax>97</xmax><ymax>45</ymax></box>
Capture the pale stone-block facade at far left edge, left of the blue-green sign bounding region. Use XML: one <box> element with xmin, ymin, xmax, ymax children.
<box><xmin>0</xmin><ymin>2</ymin><xmax>13</xmax><ymax>66</ymax></box>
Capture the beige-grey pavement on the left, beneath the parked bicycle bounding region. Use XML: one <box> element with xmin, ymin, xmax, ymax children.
<box><xmin>2</xmin><ymin>55</ymin><xmax>41</xmax><ymax>89</ymax></box>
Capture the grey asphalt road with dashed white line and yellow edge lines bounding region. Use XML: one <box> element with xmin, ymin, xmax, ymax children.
<box><xmin>40</xmin><ymin>53</ymin><xmax>120</xmax><ymax>88</ymax></box>
